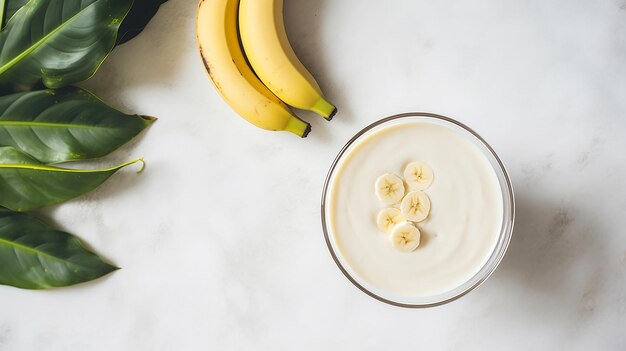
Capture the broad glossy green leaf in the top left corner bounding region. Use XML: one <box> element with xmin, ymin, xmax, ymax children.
<box><xmin>0</xmin><ymin>0</ymin><xmax>132</xmax><ymax>88</ymax></box>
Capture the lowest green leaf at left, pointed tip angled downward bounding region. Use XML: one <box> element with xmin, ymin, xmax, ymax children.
<box><xmin>0</xmin><ymin>208</ymin><xmax>118</xmax><ymax>289</ymax></box>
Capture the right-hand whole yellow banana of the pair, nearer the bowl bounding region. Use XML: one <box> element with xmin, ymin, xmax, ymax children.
<box><xmin>239</xmin><ymin>0</ymin><xmax>337</xmax><ymax>120</ymax></box>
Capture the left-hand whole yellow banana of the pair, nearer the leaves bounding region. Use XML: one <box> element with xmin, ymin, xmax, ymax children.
<box><xmin>196</xmin><ymin>0</ymin><xmax>311</xmax><ymax>138</ymax></box>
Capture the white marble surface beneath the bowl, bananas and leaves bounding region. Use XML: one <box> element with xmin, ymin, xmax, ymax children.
<box><xmin>0</xmin><ymin>0</ymin><xmax>626</xmax><ymax>351</ymax></box>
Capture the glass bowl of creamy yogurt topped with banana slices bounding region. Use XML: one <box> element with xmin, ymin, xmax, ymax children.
<box><xmin>322</xmin><ymin>113</ymin><xmax>515</xmax><ymax>307</ymax></box>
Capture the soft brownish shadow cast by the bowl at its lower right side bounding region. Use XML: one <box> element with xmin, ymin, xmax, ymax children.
<box><xmin>491</xmin><ymin>188</ymin><xmax>607</xmax><ymax>319</ymax></box>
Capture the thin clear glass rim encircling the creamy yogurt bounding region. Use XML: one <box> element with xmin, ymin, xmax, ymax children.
<box><xmin>321</xmin><ymin>112</ymin><xmax>515</xmax><ymax>308</ymax></box>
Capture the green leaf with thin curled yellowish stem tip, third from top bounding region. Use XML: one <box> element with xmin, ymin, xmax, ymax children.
<box><xmin>0</xmin><ymin>146</ymin><xmax>143</xmax><ymax>211</ymax></box>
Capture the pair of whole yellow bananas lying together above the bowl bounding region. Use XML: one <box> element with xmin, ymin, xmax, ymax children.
<box><xmin>196</xmin><ymin>0</ymin><xmax>337</xmax><ymax>138</ymax></box>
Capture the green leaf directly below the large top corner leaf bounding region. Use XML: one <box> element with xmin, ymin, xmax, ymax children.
<box><xmin>0</xmin><ymin>87</ymin><xmax>155</xmax><ymax>163</ymax></box>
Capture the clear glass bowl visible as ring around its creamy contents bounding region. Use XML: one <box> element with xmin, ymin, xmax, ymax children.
<box><xmin>321</xmin><ymin>112</ymin><xmax>515</xmax><ymax>308</ymax></box>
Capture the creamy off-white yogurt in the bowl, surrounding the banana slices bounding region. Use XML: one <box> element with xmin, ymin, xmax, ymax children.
<box><xmin>325</xmin><ymin>120</ymin><xmax>504</xmax><ymax>300</ymax></box>
